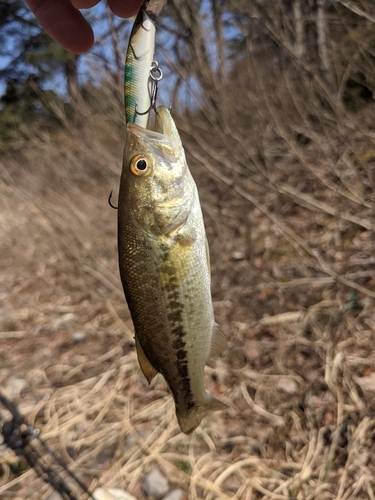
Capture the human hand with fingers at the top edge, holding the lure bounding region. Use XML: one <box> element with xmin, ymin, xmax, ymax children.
<box><xmin>26</xmin><ymin>0</ymin><xmax>142</xmax><ymax>54</ymax></box>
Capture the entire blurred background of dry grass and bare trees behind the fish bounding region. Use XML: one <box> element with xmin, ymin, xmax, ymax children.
<box><xmin>0</xmin><ymin>0</ymin><xmax>375</xmax><ymax>500</ymax></box>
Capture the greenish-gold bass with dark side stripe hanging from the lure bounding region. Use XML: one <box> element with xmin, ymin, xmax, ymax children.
<box><xmin>118</xmin><ymin>106</ymin><xmax>227</xmax><ymax>434</ymax></box>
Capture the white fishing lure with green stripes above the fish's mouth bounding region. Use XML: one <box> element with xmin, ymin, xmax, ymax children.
<box><xmin>124</xmin><ymin>0</ymin><xmax>165</xmax><ymax>128</ymax></box>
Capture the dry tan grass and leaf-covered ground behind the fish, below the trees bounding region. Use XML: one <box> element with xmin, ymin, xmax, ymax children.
<box><xmin>0</xmin><ymin>82</ymin><xmax>375</xmax><ymax>500</ymax></box>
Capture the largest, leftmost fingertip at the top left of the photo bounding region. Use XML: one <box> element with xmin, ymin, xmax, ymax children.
<box><xmin>26</xmin><ymin>0</ymin><xmax>94</xmax><ymax>54</ymax></box>
